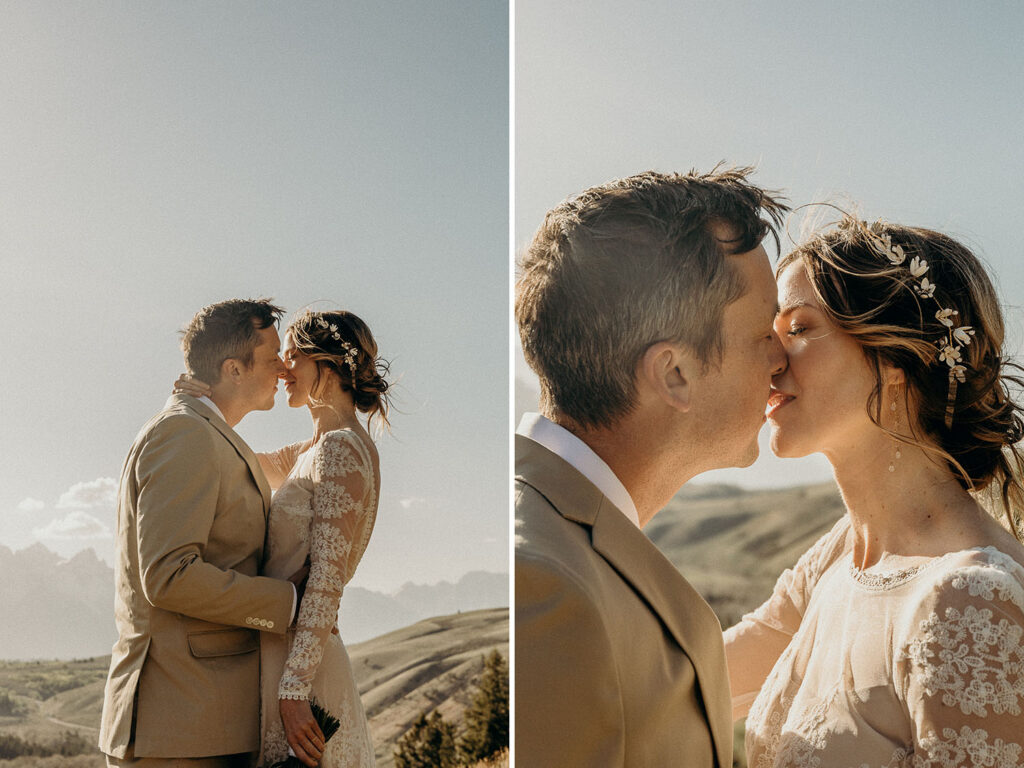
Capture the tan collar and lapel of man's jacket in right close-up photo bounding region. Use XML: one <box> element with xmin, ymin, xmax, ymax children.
<box><xmin>515</xmin><ymin>435</ymin><xmax>732</xmax><ymax>766</ymax></box>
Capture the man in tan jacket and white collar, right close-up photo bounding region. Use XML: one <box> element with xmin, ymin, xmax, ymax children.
<box><xmin>515</xmin><ymin>169</ymin><xmax>785</xmax><ymax>768</ymax></box>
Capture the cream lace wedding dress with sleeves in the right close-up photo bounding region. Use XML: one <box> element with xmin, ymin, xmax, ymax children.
<box><xmin>725</xmin><ymin>517</ymin><xmax>1024</xmax><ymax>768</ymax></box>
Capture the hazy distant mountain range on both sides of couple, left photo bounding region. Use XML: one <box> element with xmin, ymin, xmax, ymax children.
<box><xmin>0</xmin><ymin>544</ymin><xmax>509</xmax><ymax>659</ymax></box>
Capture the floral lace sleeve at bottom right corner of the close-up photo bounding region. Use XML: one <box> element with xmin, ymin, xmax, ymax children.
<box><xmin>896</xmin><ymin>550</ymin><xmax>1024</xmax><ymax>768</ymax></box>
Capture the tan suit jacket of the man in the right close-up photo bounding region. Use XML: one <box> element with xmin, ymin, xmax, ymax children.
<box><xmin>515</xmin><ymin>435</ymin><xmax>732</xmax><ymax>768</ymax></box>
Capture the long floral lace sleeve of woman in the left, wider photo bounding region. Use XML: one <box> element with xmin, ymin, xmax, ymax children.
<box><xmin>278</xmin><ymin>430</ymin><xmax>376</xmax><ymax>698</ymax></box>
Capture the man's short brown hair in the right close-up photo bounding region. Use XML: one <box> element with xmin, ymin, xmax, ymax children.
<box><xmin>515</xmin><ymin>166</ymin><xmax>788</xmax><ymax>427</ymax></box>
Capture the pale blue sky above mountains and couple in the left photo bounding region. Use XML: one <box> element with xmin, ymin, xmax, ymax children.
<box><xmin>0</xmin><ymin>0</ymin><xmax>509</xmax><ymax>589</ymax></box>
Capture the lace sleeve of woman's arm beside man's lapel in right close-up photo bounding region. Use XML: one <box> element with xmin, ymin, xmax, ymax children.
<box><xmin>723</xmin><ymin>515</ymin><xmax>850</xmax><ymax>720</ymax></box>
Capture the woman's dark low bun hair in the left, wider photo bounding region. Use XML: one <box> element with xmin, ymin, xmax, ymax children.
<box><xmin>287</xmin><ymin>309</ymin><xmax>391</xmax><ymax>428</ymax></box>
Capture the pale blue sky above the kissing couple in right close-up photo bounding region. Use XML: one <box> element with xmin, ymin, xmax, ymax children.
<box><xmin>514</xmin><ymin>0</ymin><xmax>1024</xmax><ymax>486</ymax></box>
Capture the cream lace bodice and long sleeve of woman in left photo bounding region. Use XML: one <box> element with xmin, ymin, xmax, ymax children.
<box><xmin>264</xmin><ymin>429</ymin><xmax>379</xmax><ymax>698</ymax></box>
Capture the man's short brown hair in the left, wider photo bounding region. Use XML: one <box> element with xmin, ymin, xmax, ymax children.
<box><xmin>181</xmin><ymin>299</ymin><xmax>285</xmax><ymax>384</ymax></box>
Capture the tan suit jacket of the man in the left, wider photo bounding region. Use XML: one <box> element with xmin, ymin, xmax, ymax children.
<box><xmin>99</xmin><ymin>395</ymin><xmax>293</xmax><ymax>758</ymax></box>
